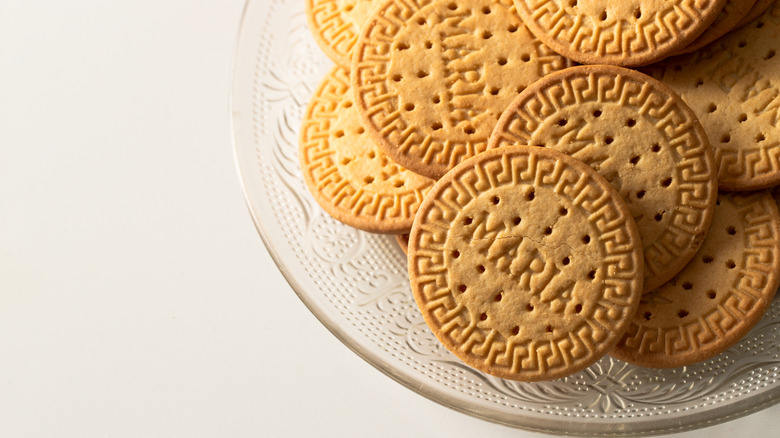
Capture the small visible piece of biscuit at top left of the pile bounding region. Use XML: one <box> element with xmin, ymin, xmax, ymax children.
<box><xmin>306</xmin><ymin>0</ymin><xmax>378</xmax><ymax>66</ymax></box>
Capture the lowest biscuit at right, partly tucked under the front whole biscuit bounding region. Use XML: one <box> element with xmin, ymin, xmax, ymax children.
<box><xmin>611</xmin><ymin>191</ymin><xmax>780</xmax><ymax>368</ymax></box>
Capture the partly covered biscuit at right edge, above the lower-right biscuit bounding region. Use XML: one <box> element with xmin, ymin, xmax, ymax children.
<box><xmin>646</xmin><ymin>2</ymin><xmax>780</xmax><ymax>191</ymax></box>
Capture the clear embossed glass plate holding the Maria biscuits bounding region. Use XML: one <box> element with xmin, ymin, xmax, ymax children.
<box><xmin>231</xmin><ymin>0</ymin><xmax>780</xmax><ymax>435</ymax></box>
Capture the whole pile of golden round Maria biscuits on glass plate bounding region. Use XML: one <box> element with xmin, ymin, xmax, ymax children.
<box><xmin>299</xmin><ymin>0</ymin><xmax>780</xmax><ymax>381</ymax></box>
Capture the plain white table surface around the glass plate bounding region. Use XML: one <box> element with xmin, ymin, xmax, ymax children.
<box><xmin>0</xmin><ymin>0</ymin><xmax>780</xmax><ymax>438</ymax></box>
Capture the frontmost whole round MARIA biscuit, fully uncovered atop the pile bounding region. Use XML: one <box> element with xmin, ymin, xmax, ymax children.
<box><xmin>409</xmin><ymin>146</ymin><xmax>643</xmax><ymax>381</ymax></box>
